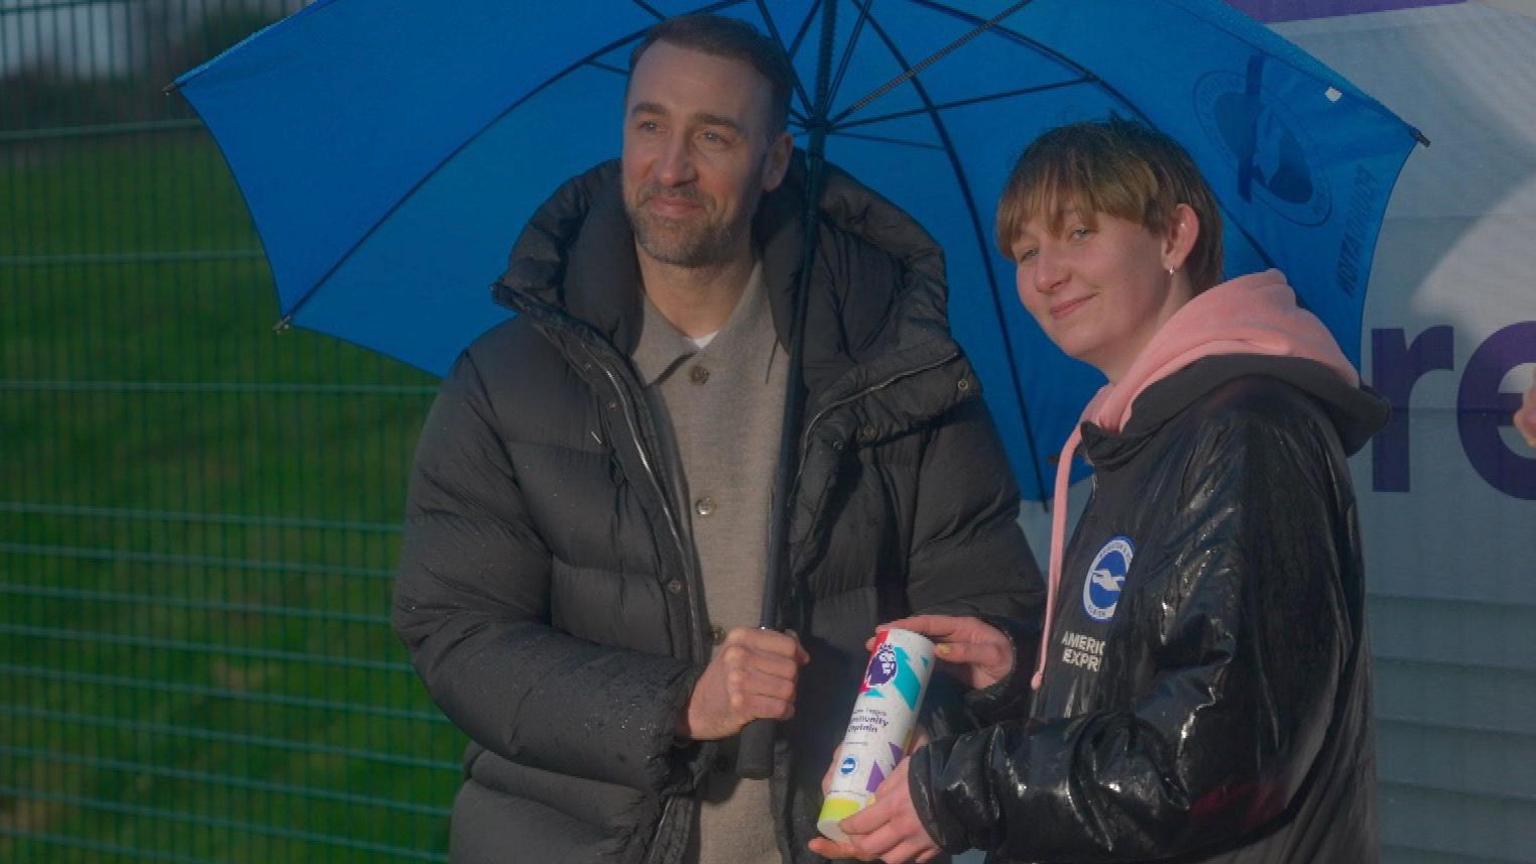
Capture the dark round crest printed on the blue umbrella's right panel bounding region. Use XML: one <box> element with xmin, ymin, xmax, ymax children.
<box><xmin>1195</xmin><ymin>72</ymin><xmax>1333</xmax><ymax>224</ymax></box>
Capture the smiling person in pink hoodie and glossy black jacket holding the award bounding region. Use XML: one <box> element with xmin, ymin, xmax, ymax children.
<box><xmin>813</xmin><ymin>120</ymin><xmax>1387</xmax><ymax>862</ymax></box>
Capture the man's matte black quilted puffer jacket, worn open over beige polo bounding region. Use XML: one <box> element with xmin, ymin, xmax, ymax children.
<box><xmin>395</xmin><ymin>163</ymin><xmax>1043</xmax><ymax>864</ymax></box>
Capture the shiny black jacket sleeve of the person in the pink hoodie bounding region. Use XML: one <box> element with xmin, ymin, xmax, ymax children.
<box><xmin>911</xmin><ymin>399</ymin><xmax>1356</xmax><ymax>862</ymax></box>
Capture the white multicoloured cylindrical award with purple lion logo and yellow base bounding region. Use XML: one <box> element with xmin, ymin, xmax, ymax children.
<box><xmin>816</xmin><ymin>630</ymin><xmax>934</xmax><ymax>842</ymax></box>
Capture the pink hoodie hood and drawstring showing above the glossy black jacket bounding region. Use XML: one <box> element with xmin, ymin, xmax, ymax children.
<box><xmin>1031</xmin><ymin>271</ymin><xmax>1359</xmax><ymax>690</ymax></box>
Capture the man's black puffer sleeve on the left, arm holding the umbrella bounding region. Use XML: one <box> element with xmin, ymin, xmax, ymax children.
<box><xmin>393</xmin><ymin>347</ymin><xmax>697</xmax><ymax>792</ymax></box>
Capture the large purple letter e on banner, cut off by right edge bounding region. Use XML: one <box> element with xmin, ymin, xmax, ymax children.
<box><xmin>1456</xmin><ymin>321</ymin><xmax>1536</xmax><ymax>501</ymax></box>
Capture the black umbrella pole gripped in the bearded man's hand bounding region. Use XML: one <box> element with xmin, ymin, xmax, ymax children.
<box><xmin>736</xmin><ymin>0</ymin><xmax>837</xmax><ymax>779</ymax></box>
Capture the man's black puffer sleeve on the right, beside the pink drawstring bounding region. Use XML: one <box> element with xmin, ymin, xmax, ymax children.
<box><xmin>906</xmin><ymin>390</ymin><xmax>1044</xmax><ymax>736</ymax></box>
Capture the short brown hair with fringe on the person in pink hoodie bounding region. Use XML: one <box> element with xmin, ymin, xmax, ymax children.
<box><xmin>997</xmin><ymin>117</ymin><xmax>1221</xmax><ymax>294</ymax></box>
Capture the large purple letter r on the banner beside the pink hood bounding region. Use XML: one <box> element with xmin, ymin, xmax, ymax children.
<box><xmin>1370</xmin><ymin>324</ymin><xmax>1449</xmax><ymax>492</ymax></box>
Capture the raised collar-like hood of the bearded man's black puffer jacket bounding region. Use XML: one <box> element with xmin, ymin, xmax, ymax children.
<box><xmin>493</xmin><ymin>151</ymin><xmax>948</xmax><ymax>361</ymax></box>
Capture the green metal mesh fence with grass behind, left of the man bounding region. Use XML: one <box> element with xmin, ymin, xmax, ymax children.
<box><xmin>0</xmin><ymin>0</ymin><xmax>461</xmax><ymax>864</ymax></box>
